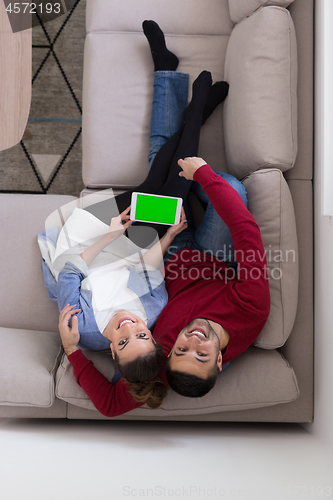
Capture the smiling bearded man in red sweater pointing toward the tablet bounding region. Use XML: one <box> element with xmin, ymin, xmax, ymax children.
<box><xmin>154</xmin><ymin>157</ymin><xmax>270</xmax><ymax>397</ymax></box>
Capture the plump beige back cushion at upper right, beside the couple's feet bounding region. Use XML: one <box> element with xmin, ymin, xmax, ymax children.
<box><xmin>223</xmin><ymin>7</ymin><xmax>297</xmax><ymax>179</ymax></box>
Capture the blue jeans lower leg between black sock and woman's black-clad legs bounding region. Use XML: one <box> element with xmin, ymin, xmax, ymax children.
<box><xmin>148</xmin><ymin>71</ymin><xmax>189</xmax><ymax>167</ymax></box>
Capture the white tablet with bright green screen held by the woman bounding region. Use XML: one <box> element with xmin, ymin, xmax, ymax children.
<box><xmin>131</xmin><ymin>192</ymin><xmax>183</xmax><ymax>225</ymax></box>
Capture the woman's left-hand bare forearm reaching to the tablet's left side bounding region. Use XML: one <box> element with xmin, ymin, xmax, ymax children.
<box><xmin>80</xmin><ymin>207</ymin><xmax>132</xmax><ymax>267</ymax></box>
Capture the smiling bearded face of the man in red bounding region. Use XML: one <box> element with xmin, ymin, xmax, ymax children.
<box><xmin>169</xmin><ymin>318</ymin><xmax>222</xmax><ymax>379</ymax></box>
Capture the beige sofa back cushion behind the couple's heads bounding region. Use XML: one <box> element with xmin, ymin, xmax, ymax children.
<box><xmin>56</xmin><ymin>347</ymin><xmax>299</xmax><ymax>418</ymax></box>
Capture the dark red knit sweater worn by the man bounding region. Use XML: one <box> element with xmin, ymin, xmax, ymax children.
<box><xmin>68</xmin><ymin>165</ymin><xmax>270</xmax><ymax>417</ymax></box>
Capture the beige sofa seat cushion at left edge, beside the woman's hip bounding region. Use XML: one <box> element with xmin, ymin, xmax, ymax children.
<box><xmin>0</xmin><ymin>194</ymin><xmax>77</xmax><ymax>331</ymax></box>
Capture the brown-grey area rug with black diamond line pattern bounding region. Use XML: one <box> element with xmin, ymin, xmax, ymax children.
<box><xmin>0</xmin><ymin>0</ymin><xmax>86</xmax><ymax>196</ymax></box>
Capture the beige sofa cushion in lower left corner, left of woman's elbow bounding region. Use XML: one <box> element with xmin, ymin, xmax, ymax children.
<box><xmin>0</xmin><ymin>328</ymin><xmax>63</xmax><ymax>408</ymax></box>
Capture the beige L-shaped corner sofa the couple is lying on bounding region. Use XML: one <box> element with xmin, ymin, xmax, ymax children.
<box><xmin>0</xmin><ymin>0</ymin><xmax>313</xmax><ymax>422</ymax></box>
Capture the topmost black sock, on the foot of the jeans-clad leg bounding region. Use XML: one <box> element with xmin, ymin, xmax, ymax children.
<box><xmin>142</xmin><ymin>21</ymin><xmax>179</xmax><ymax>71</ymax></box>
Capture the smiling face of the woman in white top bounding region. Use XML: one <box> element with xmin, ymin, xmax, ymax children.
<box><xmin>103</xmin><ymin>310</ymin><xmax>154</xmax><ymax>361</ymax></box>
